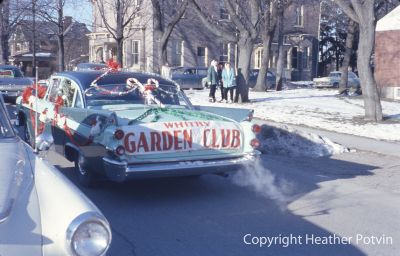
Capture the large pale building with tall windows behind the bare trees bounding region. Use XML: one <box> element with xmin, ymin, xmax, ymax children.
<box><xmin>89</xmin><ymin>0</ymin><xmax>319</xmax><ymax>80</ymax></box>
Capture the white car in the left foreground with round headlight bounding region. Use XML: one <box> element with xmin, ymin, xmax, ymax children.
<box><xmin>0</xmin><ymin>95</ymin><xmax>111</xmax><ymax>256</ymax></box>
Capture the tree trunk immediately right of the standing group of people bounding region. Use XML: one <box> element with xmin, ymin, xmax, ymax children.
<box><xmin>236</xmin><ymin>33</ymin><xmax>254</xmax><ymax>102</ymax></box>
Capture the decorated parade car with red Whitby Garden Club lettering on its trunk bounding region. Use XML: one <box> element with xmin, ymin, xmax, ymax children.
<box><xmin>17</xmin><ymin>67</ymin><xmax>260</xmax><ymax>185</ymax></box>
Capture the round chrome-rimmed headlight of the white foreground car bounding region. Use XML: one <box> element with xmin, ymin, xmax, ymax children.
<box><xmin>67</xmin><ymin>212</ymin><xmax>111</xmax><ymax>256</ymax></box>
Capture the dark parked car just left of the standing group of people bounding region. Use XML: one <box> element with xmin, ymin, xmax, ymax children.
<box><xmin>171</xmin><ymin>67</ymin><xmax>207</xmax><ymax>89</ymax></box>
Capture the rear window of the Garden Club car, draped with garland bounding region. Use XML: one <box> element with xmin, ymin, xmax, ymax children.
<box><xmin>85</xmin><ymin>84</ymin><xmax>190</xmax><ymax>108</ymax></box>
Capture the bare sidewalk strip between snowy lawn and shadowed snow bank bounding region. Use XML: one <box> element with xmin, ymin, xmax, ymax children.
<box><xmin>253</xmin><ymin>118</ymin><xmax>400</xmax><ymax>157</ymax></box>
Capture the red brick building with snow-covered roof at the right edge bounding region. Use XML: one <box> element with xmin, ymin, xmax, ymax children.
<box><xmin>375</xmin><ymin>6</ymin><xmax>400</xmax><ymax>100</ymax></box>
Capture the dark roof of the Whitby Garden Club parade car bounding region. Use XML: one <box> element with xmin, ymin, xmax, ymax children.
<box><xmin>55</xmin><ymin>71</ymin><xmax>176</xmax><ymax>90</ymax></box>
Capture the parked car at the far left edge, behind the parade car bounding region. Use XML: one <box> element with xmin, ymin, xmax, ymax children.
<box><xmin>0</xmin><ymin>65</ymin><xmax>34</xmax><ymax>101</ymax></box>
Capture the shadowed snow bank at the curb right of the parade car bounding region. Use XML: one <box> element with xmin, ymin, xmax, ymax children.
<box><xmin>259</xmin><ymin>125</ymin><xmax>349</xmax><ymax>157</ymax></box>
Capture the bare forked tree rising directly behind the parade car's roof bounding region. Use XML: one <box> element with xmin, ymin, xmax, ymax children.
<box><xmin>151</xmin><ymin>0</ymin><xmax>188</xmax><ymax>72</ymax></box>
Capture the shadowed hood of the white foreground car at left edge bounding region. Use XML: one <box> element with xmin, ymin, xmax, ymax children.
<box><xmin>0</xmin><ymin>139</ymin><xmax>33</xmax><ymax>223</ymax></box>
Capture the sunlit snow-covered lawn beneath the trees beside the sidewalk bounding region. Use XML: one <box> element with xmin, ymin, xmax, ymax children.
<box><xmin>185</xmin><ymin>88</ymin><xmax>400</xmax><ymax>141</ymax></box>
